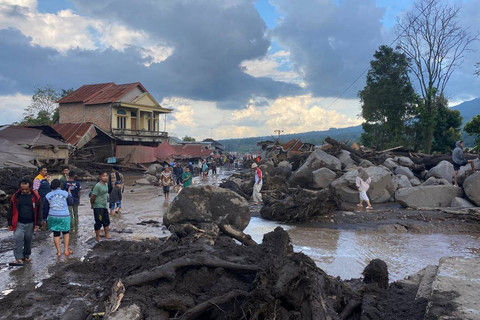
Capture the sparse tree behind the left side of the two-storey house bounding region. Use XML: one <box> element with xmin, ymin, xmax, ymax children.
<box><xmin>20</xmin><ymin>85</ymin><xmax>73</xmax><ymax>125</ymax></box>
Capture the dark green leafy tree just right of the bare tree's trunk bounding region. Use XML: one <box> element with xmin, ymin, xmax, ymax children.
<box><xmin>432</xmin><ymin>96</ymin><xmax>462</xmax><ymax>153</ymax></box>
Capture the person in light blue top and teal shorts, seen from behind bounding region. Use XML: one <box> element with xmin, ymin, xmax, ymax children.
<box><xmin>45</xmin><ymin>179</ymin><xmax>73</xmax><ymax>257</ymax></box>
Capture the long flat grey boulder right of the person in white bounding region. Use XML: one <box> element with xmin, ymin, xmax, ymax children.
<box><xmin>395</xmin><ymin>185</ymin><xmax>463</xmax><ymax>208</ymax></box>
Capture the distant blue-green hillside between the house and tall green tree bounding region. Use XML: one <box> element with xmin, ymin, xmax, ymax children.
<box><xmin>219</xmin><ymin>126</ymin><xmax>363</xmax><ymax>153</ymax></box>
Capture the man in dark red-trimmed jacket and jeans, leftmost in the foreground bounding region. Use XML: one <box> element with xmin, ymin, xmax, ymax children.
<box><xmin>7</xmin><ymin>179</ymin><xmax>43</xmax><ymax>266</ymax></box>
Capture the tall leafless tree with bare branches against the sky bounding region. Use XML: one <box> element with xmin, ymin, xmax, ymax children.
<box><xmin>397</xmin><ymin>0</ymin><xmax>478</xmax><ymax>153</ymax></box>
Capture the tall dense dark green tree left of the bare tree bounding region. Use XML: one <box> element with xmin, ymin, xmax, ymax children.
<box><xmin>358</xmin><ymin>46</ymin><xmax>416</xmax><ymax>149</ymax></box>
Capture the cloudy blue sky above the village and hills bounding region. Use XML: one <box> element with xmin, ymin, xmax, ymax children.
<box><xmin>0</xmin><ymin>0</ymin><xmax>480</xmax><ymax>139</ymax></box>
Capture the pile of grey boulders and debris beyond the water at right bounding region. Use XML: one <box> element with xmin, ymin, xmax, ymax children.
<box><xmin>223</xmin><ymin>138</ymin><xmax>480</xmax><ymax>222</ymax></box>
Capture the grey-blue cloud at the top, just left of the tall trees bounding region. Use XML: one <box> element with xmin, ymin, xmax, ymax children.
<box><xmin>273</xmin><ymin>0</ymin><xmax>386</xmax><ymax>98</ymax></box>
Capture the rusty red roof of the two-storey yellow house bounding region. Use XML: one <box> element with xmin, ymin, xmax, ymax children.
<box><xmin>57</xmin><ymin>82</ymin><xmax>147</xmax><ymax>105</ymax></box>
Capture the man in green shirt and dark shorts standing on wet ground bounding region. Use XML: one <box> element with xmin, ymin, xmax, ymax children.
<box><xmin>90</xmin><ymin>171</ymin><xmax>110</xmax><ymax>241</ymax></box>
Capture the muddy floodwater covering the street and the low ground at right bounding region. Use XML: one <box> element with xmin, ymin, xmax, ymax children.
<box><xmin>0</xmin><ymin>170</ymin><xmax>480</xmax><ymax>295</ymax></box>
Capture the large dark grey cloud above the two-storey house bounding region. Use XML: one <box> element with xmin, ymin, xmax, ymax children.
<box><xmin>0</xmin><ymin>0</ymin><xmax>301</xmax><ymax>109</ymax></box>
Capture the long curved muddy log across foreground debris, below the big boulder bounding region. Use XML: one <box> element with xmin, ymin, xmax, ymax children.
<box><xmin>123</xmin><ymin>254</ymin><xmax>258</xmax><ymax>287</ymax></box>
